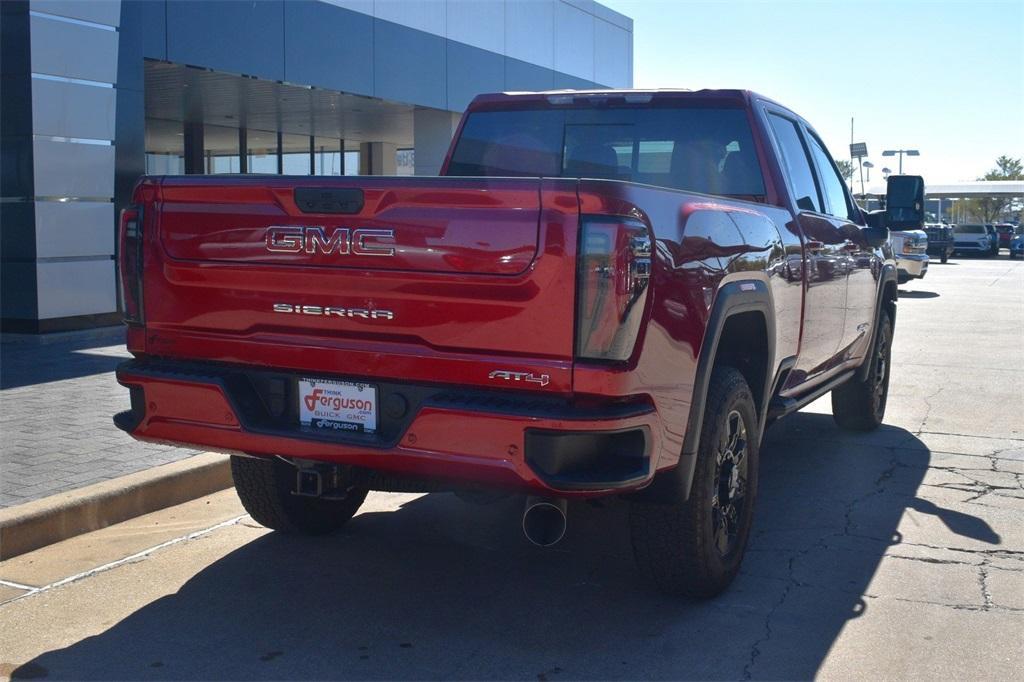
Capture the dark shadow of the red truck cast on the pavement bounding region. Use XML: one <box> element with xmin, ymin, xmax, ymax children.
<box><xmin>14</xmin><ymin>414</ymin><xmax>999</xmax><ymax>682</ymax></box>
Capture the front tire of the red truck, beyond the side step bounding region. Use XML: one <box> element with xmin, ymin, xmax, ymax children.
<box><xmin>831</xmin><ymin>309</ymin><xmax>893</xmax><ymax>431</ymax></box>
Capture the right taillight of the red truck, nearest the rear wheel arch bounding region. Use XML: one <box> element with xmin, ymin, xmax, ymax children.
<box><xmin>575</xmin><ymin>216</ymin><xmax>651</xmax><ymax>361</ymax></box>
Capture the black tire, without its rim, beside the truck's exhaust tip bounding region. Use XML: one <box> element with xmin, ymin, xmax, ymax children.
<box><xmin>630</xmin><ymin>367</ymin><xmax>760</xmax><ymax>598</ymax></box>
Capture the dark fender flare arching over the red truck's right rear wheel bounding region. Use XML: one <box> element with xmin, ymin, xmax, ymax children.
<box><xmin>636</xmin><ymin>280</ymin><xmax>775</xmax><ymax>503</ymax></box>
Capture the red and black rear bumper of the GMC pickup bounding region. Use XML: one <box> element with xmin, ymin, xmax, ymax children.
<box><xmin>114</xmin><ymin>360</ymin><xmax>660</xmax><ymax>496</ymax></box>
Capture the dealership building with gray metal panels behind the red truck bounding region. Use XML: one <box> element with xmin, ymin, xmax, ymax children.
<box><xmin>0</xmin><ymin>0</ymin><xmax>633</xmax><ymax>333</ymax></box>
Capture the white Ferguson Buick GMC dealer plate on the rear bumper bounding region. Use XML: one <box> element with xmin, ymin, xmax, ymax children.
<box><xmin>299</xmin><ymin>379</ymin><xmax>377</xmax><ymax>433</ymax></box>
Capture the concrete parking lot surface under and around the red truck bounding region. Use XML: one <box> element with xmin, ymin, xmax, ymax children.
<box><xmin>0</xmin><ymin>255</ymin><xmax>1024</xmax><ymax>682</ymax></box>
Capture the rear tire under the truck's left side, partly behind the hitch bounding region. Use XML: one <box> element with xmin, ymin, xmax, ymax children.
<box><xmin>231</xmin><ymin>456</ymin><xmax>368</xmax><ymax>536</ymax></box>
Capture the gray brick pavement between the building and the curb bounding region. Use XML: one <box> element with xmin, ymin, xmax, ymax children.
<box><xmin>0</xmin><ymin>330</ymin><xmax>200</xmax><ymax>507</ymax></box>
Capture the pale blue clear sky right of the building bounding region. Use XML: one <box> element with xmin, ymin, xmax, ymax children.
<box><xmin>599</xmin><ymin>0</ymin><xmax>1024</xmax><ymax>184</ymax></box>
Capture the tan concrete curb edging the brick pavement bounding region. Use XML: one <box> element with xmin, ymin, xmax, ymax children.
<box><xmin>0</xmin><ymin>453</ymin><xmax>232</xmax><ymax>560</ymax></box>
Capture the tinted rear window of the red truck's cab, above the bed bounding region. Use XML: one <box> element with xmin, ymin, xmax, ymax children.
<box><xmin>447</xmin><ymin>106</ymin><xmax>765</xmax><ymax>198</ymax></box>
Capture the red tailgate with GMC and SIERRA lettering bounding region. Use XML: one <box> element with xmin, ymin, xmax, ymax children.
<box><xmin>143</xmin><ymin>177</ymin><xmax>578</xmax><ymax>391</ymax></box>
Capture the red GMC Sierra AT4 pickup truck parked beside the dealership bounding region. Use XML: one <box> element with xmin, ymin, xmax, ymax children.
<box><xmin>115</xmin><ymin>90</ymin><xmax>924</xmax><ymax>596</ymax></box>
